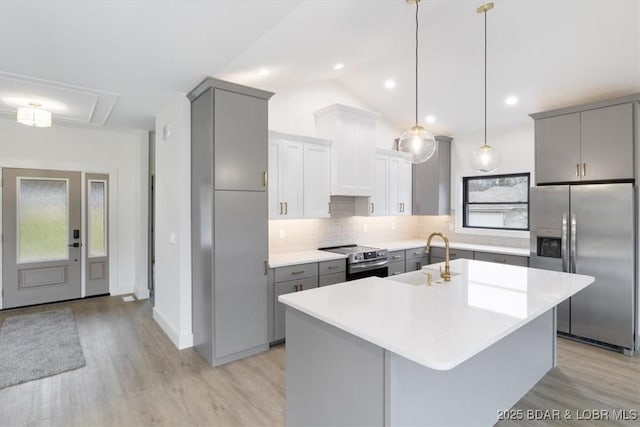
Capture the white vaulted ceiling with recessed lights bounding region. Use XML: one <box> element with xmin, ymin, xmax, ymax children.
<box><xmin>0</xmin><ymin>0</ymin><xmax>640</xmax><ymax>134</ymax></box>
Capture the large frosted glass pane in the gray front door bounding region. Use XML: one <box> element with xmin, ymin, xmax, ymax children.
<box><xmin>17</xmin><ymin>178</ymin><xmax>69</xmax><ymax>263</ymax></box>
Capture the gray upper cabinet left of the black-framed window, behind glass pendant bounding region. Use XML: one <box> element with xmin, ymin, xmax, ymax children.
<box><xmin>412</xmin><ymin>136</ymin><xmax>452</xmax><ymax>215</ymax></box>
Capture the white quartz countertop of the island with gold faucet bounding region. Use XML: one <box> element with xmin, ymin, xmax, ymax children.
<box><xmin>279</xmin><ymin>259</ymin><xmax>594</xmax><ymax>370</ymax></box>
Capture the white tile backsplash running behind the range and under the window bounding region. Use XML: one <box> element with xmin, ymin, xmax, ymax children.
<box><xmin>269</xmin><ymin>196</ymin><xmax>529</xmax><ymax>254</ymax></box>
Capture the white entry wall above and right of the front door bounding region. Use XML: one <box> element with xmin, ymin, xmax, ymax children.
<box><xmin>0</xmin><ymin>118</ymin><xmax>149</xmax><ymax>304</ymax></box>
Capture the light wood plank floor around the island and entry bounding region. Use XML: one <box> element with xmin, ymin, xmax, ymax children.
<box><xmin>0</xmin><ymin>297</ymin><xmax>640</xmax><ymax>427</ymax></box>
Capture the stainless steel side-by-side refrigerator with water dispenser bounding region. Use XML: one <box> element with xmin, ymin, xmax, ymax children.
<box><xmin>529</xmin><ymin>183</ymin><xmax>637</xmax><ymax>352</ymax></box>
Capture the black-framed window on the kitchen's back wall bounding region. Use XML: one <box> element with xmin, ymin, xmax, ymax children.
<box><xmin>462</xmin><ymin>173</ymin><xmax>530</xmax><ymax>231</ymax></box>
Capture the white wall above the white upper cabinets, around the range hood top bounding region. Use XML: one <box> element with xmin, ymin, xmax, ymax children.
<box><xmin>269</xmin><ymin>81</ymin><xmax>403</xmax><ymax>149</ymax></box>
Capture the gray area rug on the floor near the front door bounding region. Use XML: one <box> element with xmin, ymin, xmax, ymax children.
<box><xmin>0</xmin><ymin>308</ymin><xmax>85</xmax><ymax>389</ymax></box>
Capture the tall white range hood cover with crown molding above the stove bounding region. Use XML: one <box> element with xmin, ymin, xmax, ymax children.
<box><xmin>315</xmin><ymin>104</ymin><xmax>379</xmax><ymax>197</ymax></box>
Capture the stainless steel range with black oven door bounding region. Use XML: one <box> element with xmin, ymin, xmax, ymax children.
<box><xmin>320</xmin><ymin>245</ymin><xmax>389</xmax><ymax>281</ymax></box>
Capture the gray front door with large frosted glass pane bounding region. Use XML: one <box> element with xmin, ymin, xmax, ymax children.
<box><xmin>2</xmin><ymin>169</ymin><xmax>82</xmax><ymax>308</ymax></box>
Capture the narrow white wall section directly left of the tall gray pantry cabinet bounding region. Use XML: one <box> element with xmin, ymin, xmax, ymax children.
<box><xmin>153</xmin><ymin>94</ymin><xmax>193</xmax><ymax>349</ymax></box>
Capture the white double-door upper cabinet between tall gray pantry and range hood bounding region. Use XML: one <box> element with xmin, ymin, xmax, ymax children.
<box><xmin>269</xmin><ymin>131</ymin><xmax>331</xmax><ymax>219</ymax></box>
